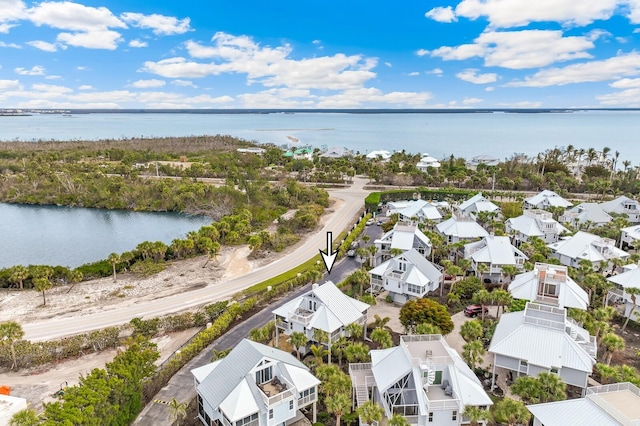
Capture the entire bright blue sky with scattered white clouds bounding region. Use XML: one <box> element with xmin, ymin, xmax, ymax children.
<box><xmin>0</xmin><ymin>0</ymin><xmax>640</xmax><ymax>108</ymax></box>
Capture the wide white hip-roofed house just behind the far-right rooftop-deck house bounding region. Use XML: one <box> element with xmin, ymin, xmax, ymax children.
<box><xmin>547</xmin><ymin>231</ymin><xmax>630</xmax><ymax>271</ymax></box>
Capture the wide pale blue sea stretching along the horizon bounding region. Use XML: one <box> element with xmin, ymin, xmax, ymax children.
<box><xmin>0</xmin><ymin>111</ymin><xmax>640</xmax><ymax>167</ymax></box>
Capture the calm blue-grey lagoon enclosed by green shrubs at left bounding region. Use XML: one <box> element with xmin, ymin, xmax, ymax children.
<box><xmin>0</xmin><ymin>203</ymin><xmax>211</xmax><ymax>268</ymax></box>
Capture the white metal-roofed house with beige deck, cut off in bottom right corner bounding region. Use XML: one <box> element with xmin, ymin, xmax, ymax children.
<box><xmin>527</xmin><ymin>382</ymin><xmax>640</xmax><ymax>426</ymax></box>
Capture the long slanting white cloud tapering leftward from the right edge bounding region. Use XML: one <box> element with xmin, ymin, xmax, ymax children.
<box><xmin>507</xmin><ymin>52</ymin><xmax>640</xmax><ymax>87</ymax></box>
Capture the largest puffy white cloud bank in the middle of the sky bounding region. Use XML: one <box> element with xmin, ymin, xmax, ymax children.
<box><xmin>141</xmin><ymin>33</ymin><xmax>377</xmax><ymax>90</ymax></box>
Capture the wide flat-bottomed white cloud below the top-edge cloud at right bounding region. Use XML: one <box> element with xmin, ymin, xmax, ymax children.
<box><xmin>430</xmin><ymin>30</ymin><xmax>594</xmax><ymax>69</ymax></box>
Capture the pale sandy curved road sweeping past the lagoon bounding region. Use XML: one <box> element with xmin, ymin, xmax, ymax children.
<box><xmin>22</xmin><ymin>177</ymin><xmax>369</xmax><ymax>341</ymax></box>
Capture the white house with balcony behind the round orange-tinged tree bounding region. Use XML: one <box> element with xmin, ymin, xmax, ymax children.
<box><xmin>369</xmin><ymin>249</ymin><xmax>442</xmax><ymax>304</ymax></box>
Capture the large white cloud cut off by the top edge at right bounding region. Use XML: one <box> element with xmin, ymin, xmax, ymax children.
<box><xmin>455</xmin><ymin>0</ymin><xmax>616</xmax><ymax>28</ymax></box>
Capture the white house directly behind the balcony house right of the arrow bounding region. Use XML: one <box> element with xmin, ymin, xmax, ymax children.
<box><xmin>373</xmin><ymin>222</ymin><xmax>431</xmax><ymax>265</ymax></box>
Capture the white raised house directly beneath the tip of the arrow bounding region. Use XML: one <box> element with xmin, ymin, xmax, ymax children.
<box><xmin>273</xmin><ymin>281</ymin><xmax>369</xmax><ymax>354</ymax></box>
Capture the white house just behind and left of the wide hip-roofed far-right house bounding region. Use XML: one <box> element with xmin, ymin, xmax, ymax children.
<box><xmin>505</xmin><ymin>209</ymin><xmax>569</xmax><ymax>247</ymax></box>
